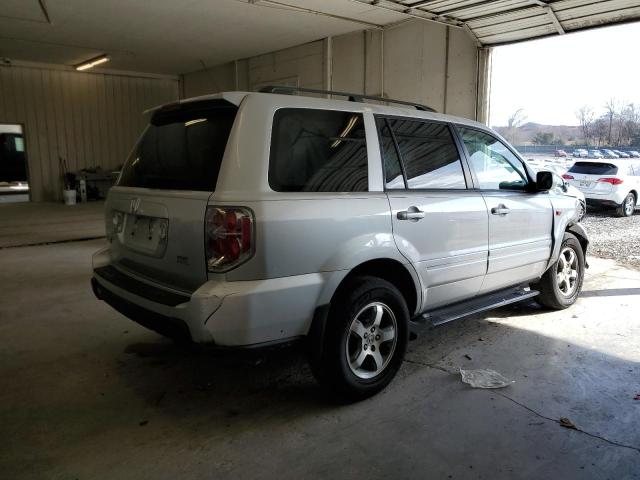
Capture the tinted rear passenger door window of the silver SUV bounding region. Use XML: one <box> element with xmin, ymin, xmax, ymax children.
<box><xmin>378</xmin><ymin>118</ymin><xmax>467</xmax><ymax>190</ymax></box>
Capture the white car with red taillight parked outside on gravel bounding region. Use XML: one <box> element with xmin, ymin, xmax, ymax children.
<box><xmin>563</xmin><ymin>159</ymin><xmax>640</xmax><ymax>217</ymax></box>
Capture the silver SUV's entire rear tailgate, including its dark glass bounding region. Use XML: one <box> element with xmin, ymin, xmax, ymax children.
<box><xmin>106</xmin><ymin>99</ymin><xmax>238</xmax><ymax>292</ymax></box>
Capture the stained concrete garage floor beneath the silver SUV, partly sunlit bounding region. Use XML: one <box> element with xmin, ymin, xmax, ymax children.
<box><xmin>0</xmin><ymin>240</ymin><xmax>640</xmax><ymax>479</ymax></box>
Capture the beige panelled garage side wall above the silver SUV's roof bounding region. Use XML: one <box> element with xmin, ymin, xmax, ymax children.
<box><xmin>183</xmin><ymin>20</ymin><xmax>478</xmax><ymax>118</ymax></box>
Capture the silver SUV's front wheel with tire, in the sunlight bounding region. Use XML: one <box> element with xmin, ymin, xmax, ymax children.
<box><xmin>531</xmin><ymin>233</ymin><xmax>584</xmax><ymax>310</ymax></box>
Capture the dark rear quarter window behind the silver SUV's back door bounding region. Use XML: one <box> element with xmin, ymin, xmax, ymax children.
<box><xmin>269</xmin><ymin>108</ymin><xmax>369</xmax><ymax>192</ymax></box>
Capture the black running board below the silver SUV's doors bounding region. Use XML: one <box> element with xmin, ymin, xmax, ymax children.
<box><xmin>409</xmin><ymin>288</ymin><xmax>540</xmax><ymax>338</ymax></box>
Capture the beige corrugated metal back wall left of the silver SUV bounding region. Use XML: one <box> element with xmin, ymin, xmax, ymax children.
<box><xmin>0</xmin><ymin>66</ymin><xmax>179</xmax><ymax>201</ymax></box>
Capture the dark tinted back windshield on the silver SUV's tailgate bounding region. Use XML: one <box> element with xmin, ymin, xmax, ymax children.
<box><xmin>118</xmin><ymin>100</ymin><xmax>238</xmax><ymax>192</ymax></box>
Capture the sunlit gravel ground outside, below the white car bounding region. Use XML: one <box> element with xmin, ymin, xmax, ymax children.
<box><xmin>582</xmin><ymin>210</ymin><xmax>640</xmax><ymax>268</ymax></box>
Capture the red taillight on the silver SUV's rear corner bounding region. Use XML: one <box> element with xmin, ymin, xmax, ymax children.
<box><xmin>205</xmin><ymin>207</ymin><xmax>255</xmax><ymax>273</ymax></box>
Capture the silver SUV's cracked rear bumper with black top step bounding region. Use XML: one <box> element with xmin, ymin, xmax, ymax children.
<box><xmin>91</xmin><ymin>248</ymin><xmax>347</xmax><ymax>347</ymax></box>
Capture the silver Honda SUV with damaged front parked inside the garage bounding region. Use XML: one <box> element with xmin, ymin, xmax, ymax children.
<box><xmin>92</xmin><ymin>87</ymin><xmax>588</xmax><ymax>398</ymax></box>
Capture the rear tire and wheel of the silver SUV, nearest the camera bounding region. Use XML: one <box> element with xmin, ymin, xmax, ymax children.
<box><xmin>311</xmin><ymin>276</ymin><xmax>409</xmax><ymax>401</ymax></box>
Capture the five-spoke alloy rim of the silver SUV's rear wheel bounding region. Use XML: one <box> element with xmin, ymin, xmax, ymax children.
<box><xmin>345</xmin><ymin>302</ymin><xmax>398</xmax><ymax>379</ymax></box>
